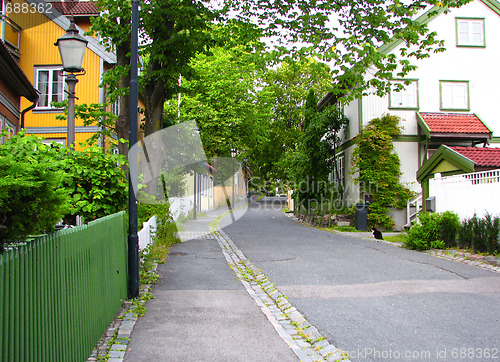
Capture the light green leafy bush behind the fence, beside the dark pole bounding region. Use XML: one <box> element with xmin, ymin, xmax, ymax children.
<box><xmin>0</xmin><ymin>131</ymin><xmax>128</xmax><ymax>223</ymax></box>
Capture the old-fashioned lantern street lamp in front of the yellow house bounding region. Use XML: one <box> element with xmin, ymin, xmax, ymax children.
<box><xmin>54</xmin><ymin>19</ymin><xmax>88</xmax><ymax>149</ymax></box>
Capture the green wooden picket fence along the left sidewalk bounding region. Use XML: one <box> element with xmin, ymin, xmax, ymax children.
<box><xmin>0</xmin><ymin>212</ymin><xmax>127</xmax><ymax>362</ymax></box>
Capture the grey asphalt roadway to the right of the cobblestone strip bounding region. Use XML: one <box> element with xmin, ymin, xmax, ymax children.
<box><xmin>224</xmin><ymin>198</ymin><xmax>500</xmax><ymax>361</ymax></box>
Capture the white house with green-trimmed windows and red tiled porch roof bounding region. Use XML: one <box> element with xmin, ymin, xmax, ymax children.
<box><xmin>320</xmin><ymin>0</ymin><xmax>500</xmax><ymax>221</ymax></box>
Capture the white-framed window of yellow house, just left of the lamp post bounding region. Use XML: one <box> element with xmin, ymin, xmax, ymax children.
<box><xmin>35</xmin><ymin>67</ymin><xmax>66</xmax><ymax>109</ymax></box>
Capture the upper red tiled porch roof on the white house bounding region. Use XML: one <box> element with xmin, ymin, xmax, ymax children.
<box><xmin>420</xmin><ymin>112</ymin><xmax>491</xmax><ymax>134</ymax></box>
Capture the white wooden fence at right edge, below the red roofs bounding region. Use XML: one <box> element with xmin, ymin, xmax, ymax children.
<box><xmin>429</xmin><ymin>170</ymin><xmax>500</xmax><ymax>219</ymax></box>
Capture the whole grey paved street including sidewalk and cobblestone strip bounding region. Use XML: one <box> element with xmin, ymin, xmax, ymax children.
<box><xmin>125</xmin><ymin>198</ymin><xmax>500</xmax><ymax>361</ymax></box>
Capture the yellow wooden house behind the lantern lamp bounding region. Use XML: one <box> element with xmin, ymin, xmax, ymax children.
<box><xmin>0</xmin><ymin>0</ymin><xmax>116</xmax><ymax>148</ymax></box>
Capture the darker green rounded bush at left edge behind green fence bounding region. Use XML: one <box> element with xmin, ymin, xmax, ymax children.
<box><xmin>0</xmin><ymin>156</ymin><xmax>70</xmax><ymax>247</ymax></box>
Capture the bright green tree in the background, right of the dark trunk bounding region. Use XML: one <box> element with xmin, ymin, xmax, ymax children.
<box><xmin>167</xmin><ymin>46</ymin><xmax>270</xmax><ymax>157</ymax></box>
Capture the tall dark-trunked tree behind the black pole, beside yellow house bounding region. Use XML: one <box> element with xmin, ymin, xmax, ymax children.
<box><xmin>90</xmin><ymin>0</ymin><xmax>216</xmax><ymax>153</ymax></box>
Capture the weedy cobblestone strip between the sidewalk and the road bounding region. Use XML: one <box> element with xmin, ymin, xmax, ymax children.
<box><xmin>204</xmin><ymin>229</ymin><xmax>349</xmax><ymax>362</ymax></box>
